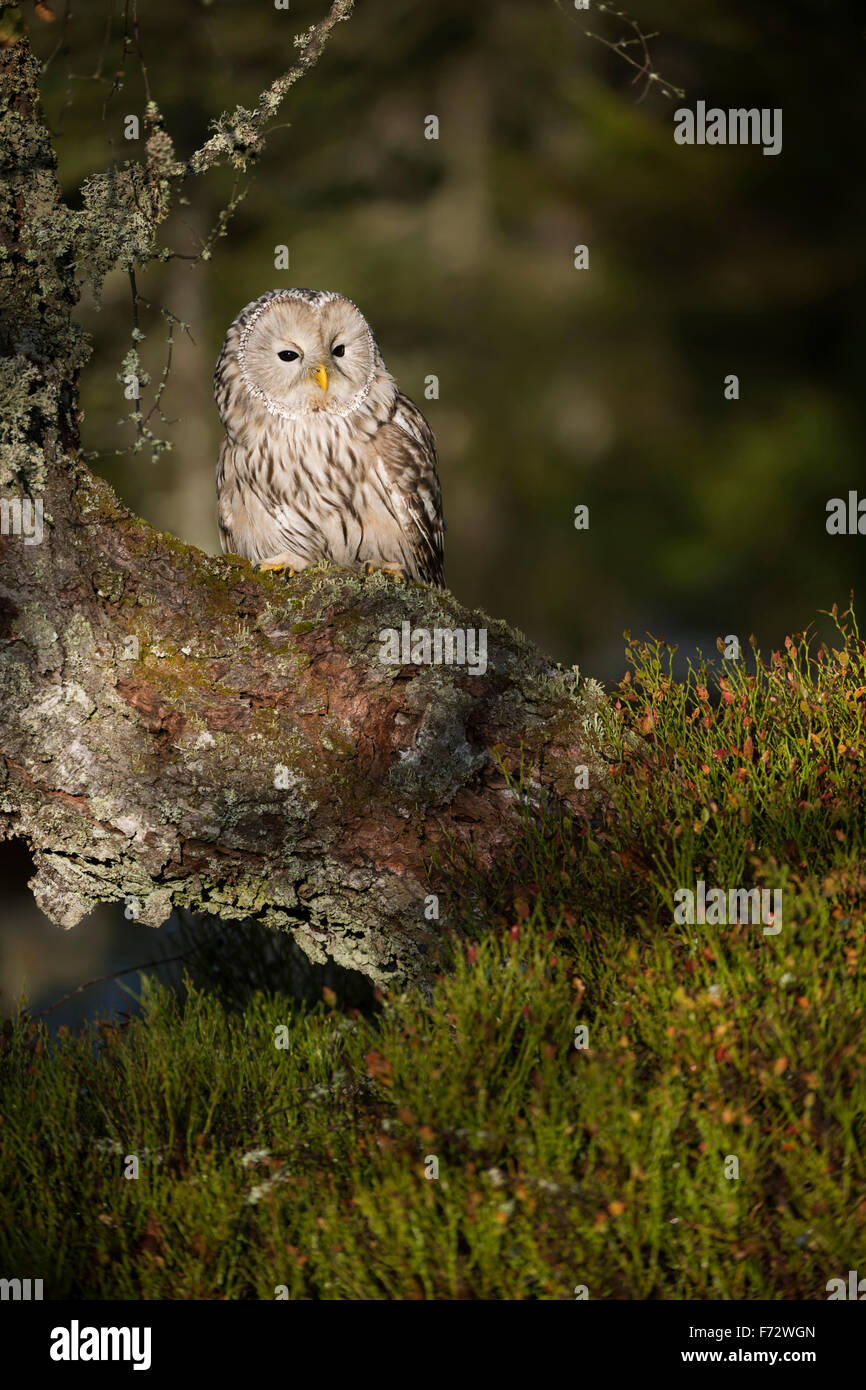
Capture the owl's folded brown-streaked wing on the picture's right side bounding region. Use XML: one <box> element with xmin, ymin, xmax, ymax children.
<box><xmin>373</xmin><ymin>392</ymin><xmax>445</xmax><ymax>588</ymax></box>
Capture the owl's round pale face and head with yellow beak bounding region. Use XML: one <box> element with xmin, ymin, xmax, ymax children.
<box><xmin>221</xmin><ymin>289</ymin><xmax>385</xmax><ymax>420</ymax></box>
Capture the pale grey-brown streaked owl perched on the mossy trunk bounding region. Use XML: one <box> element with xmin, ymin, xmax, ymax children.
<box><xmin>214</xmin><ymin>289</ymin><xmax>445</xmax><ymax>585</ymax></box>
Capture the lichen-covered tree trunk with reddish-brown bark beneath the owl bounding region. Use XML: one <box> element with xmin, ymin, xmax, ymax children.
<box><xmin>0</xmin><ymin>6</ymin><xmax>605</xmax><ymax>984</ymax></box>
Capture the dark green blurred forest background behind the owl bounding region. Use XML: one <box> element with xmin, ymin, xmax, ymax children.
<box><xmin>27</xmin><ymin>0</ymin><xmax>866</xmax><ymax>677</ymax></box>
